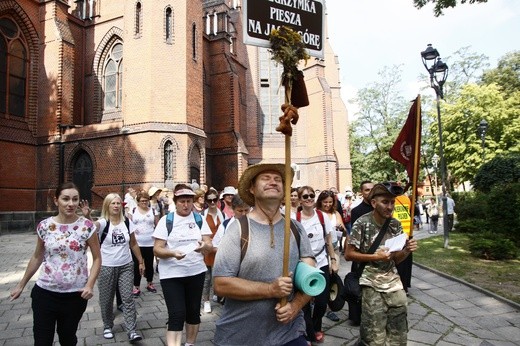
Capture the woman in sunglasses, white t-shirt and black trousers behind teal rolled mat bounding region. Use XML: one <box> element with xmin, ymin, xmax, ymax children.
<box><xmin>296</xmin><ymin>186</ymin><xmax>338</xmax><ymax>343</ymax></box>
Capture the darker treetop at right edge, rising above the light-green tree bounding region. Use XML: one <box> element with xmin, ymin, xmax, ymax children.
<box><xmin>482</xmin><ymin>51</ymin><xmax>520</xmax><ymax>97</ymax></box>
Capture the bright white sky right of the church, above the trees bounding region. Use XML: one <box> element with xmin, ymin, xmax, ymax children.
<box><xmin>325</xmin><ymin>0</ymin><xmax>520</xmax><ymax>119</ymax></box>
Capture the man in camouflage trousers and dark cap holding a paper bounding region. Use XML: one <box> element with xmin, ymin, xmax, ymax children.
<box><xmin>345</xmin><ymin>182</ymin><xmax>417</xmax><ymax>345</ymax></box>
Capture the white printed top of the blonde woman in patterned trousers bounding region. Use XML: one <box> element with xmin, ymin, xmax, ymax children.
<box><xmin>98</xmin><ymin>218</ymin><xmax>132</xmax><ymax>267</ymax></box>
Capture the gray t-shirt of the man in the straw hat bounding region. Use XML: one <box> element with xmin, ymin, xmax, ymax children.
<box><xmin>213</xmin><ymin>219</ymin><xmax>313</xmax><ymax>346</ymax></box>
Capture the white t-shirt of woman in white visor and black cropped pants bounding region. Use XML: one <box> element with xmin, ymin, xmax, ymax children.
<box><xmin>153</xmin><ymin>212</ymin><xmax>212</xmax><ymax>280</ymax></box>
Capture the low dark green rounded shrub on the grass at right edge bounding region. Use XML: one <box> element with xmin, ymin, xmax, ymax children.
<box><xmin>469</xmin><ymin>232</ymin><xmax>518</xmax><ymax>260</ymax></box>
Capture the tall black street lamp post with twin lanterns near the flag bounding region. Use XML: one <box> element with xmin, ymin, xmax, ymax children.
<box><xmin>421</xmin><ymin>44</ymin><xmax>449</xmax><ymax>248</ymax></box>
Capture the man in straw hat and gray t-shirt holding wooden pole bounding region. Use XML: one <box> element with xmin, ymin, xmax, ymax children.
<box><xmin>214</xmin><ymin>164</ymin><xmax>315</xmax><ymax>346</ymax></box>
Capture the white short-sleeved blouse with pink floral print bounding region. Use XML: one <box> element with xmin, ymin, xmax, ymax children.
<box><xmin>36</xmin><ymin>217</ymin><xmax>96</xmax><ymax>293</ymax></box>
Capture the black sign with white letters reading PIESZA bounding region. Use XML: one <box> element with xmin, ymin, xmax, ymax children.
<box><xmin>242</xmin><ymin>0</ymin><xmax>325</xmax><ymax>58</ymax></box>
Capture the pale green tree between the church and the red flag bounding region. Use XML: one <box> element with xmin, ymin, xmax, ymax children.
<box><xmin>350</xmin><ymin>66</ymin><xmax>411</xmax><ymax>186</ymax></box>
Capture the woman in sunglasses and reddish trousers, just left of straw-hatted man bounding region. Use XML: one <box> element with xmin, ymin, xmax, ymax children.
<box><xmin>202</xmin><ymin>187</ymin><xmax>225</xmax><ymax>313</ymax></box>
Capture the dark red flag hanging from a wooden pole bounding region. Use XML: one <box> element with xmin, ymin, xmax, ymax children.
<box><xmin>390</xmin><ymin>96</ymin><xmax>421</xmax><ymax>183</ymax></box>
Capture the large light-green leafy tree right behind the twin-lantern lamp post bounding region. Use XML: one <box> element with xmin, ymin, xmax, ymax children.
<box><xmin>432</xmin><ymin>84</ymin><xmax>520</xmax><ymax>183</ymax></box>
